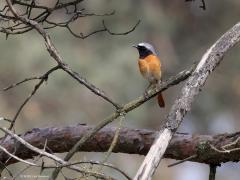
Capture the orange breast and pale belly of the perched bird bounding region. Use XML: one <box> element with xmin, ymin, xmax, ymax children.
<box><xmin>138</xmin><ymin>55</ymin><xmax>161</xmax><ymax>83</ymax></box>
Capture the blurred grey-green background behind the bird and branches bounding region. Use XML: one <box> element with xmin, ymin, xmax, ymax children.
<box><xmin>0</xmin><ymin>0</ymin><xmax>240</xmax><ymax>180</ymax></box>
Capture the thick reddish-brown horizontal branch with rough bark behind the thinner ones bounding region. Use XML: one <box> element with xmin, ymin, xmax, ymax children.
<box><xmin>0</xmin><ymin>125</ymin><xmax>240</xmax><ymax>165</ymax></box>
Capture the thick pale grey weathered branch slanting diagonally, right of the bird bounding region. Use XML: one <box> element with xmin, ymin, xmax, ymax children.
<box><xmin>134</xmin><ymin>23</ymin><xmax>240</xmax><ymax>180</ymax></box>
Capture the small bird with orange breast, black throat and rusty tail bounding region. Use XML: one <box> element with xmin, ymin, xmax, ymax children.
<box><xmin>133</xmin><ymin>42</ymin><xmax>165</xmax><ymax>108</ymax></box>
